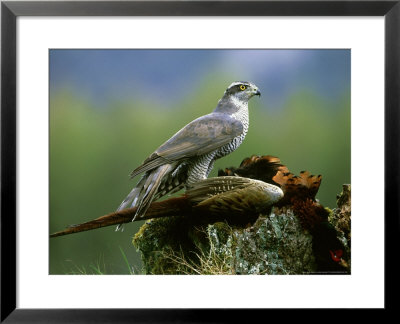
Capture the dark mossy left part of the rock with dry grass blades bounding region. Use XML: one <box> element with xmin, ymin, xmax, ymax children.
<box><xmin>133</xmin><ymin>217</ymin><xmax>233</xmax><ymax>274</ymax></box>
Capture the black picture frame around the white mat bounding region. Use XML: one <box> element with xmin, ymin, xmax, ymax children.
<box><xmin>1</xmin><ymin>0</ymin><xmax>400</xmax><ymax>323</ymax></box>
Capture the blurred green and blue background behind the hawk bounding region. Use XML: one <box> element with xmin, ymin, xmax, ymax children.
<box><xmin>49</xmin><ymin>50</ymin><xmax>351</xmax><ymax>274</ymax></box>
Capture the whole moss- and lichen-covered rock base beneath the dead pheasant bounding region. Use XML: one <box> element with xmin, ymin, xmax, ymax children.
<box><xmin>133</xmin><ymin>185</ymin><xmax>351</xmax><ymax>274</ymax></box>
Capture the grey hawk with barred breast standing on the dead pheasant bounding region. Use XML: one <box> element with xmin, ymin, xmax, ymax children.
<box><xmin>117</xmin><ymin>81</ymin><xmax>261</xmax><ymax>223</ymax></box>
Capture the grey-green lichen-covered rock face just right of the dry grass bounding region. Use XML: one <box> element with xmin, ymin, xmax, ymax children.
<box><xmin>230</xmin><ymin>208</ymin><xmax>315</xmax><ymax>274</ymax></box>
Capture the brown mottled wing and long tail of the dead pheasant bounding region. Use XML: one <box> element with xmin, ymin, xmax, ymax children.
<box><xmin>50</xmin><ymin>176</ymin><xmax>283</xmax><ymax>237</ymax></box>
